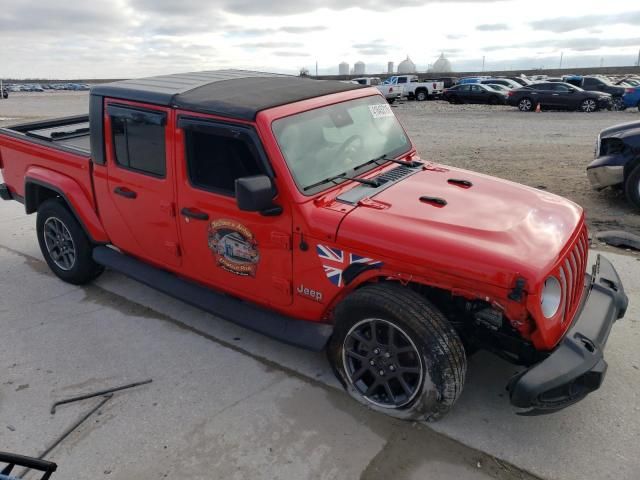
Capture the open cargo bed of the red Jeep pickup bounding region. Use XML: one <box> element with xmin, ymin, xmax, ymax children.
<box><xmin>0</xmin><ymin>115</ymin><xmax>91</xmax><ymax>156</ymax></box>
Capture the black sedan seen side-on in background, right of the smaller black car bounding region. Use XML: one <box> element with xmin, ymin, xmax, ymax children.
<box><xmin>507</xmin><ymin>82</ymin><xmax>611</xmax><ymax>112</ymax></box>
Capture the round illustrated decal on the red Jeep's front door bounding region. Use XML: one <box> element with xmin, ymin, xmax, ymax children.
<box><xmin>208</xmin><ymin>219</ymin><xmax>260</xmax><ymax>277</ymax></box>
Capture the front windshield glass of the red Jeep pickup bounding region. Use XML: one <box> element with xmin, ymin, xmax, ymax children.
<box><xmin>273</xmin><ymin>95</ymin><xmax>411</xmax><ymax>195</ymax></box>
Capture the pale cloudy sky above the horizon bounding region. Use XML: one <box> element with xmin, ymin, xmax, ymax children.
<box><xmin>0</xmin><ymin>0</ymin><xmax>640</xmax><ymax>78</ymax></box>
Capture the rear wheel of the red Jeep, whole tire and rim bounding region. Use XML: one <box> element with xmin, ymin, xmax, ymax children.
<box><xmin>36</xmin><ymin>198</ymin><xmax>104</xmax><ymax>285</ymax></box>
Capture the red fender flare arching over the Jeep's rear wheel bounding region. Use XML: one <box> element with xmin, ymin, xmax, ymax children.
<box><xmin>24</xmin><ymin>166</ymin><xmax>109</xmax><ymax>243</ymax></box>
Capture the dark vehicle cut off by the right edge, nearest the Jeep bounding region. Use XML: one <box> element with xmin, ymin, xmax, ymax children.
<box><xmin>587</xmin><ymin>122</ymin><xmax>640</xmax><ymax>208</ymax></box>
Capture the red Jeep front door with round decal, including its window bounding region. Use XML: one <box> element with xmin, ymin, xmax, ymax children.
<box><xmin>176</xmin><ymin>114</ymin><xmax>292</xmax><ymax>305</ymax></box>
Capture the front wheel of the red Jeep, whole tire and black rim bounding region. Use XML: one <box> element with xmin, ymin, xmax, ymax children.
<box><xmin>328</xmin><ymin>283</ymin><xmax>467</xmax><ymax>420</ymax></box>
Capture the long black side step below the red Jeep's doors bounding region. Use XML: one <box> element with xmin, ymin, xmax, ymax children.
<box><xmin>93</xmin><ymin>246</ymin><xmax>333</xmax><ymax>351</ymax></box>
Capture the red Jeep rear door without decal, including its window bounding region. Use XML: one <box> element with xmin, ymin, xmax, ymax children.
<box><xmin>101</xmin><ymin>101</ymin><xmax>181</xmax><ymax>267</ymax></box>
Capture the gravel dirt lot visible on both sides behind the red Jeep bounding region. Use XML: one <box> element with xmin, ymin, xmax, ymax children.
<box><xmin>0</xmin><ymin>92</ymin><xmax>640</xmax><ymax>244</ymax></box>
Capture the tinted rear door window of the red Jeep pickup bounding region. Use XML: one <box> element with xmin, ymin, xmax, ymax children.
<box><xmin>107</xmin><ymin>105</ymin><xmax>166</xmax><ymax>177</ymax></box>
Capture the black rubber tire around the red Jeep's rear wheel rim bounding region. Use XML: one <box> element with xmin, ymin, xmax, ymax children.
<box><xmin>36</xmin><ymin>198</ymin><xmax>104</xmax><ymax>285</ymax></box>
